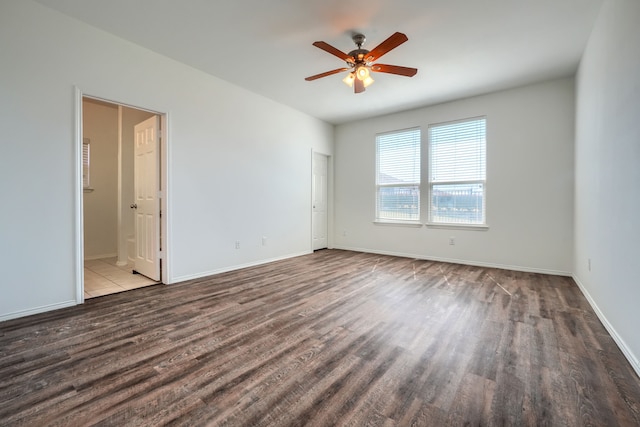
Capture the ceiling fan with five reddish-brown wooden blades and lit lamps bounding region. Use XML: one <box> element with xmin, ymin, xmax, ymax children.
<box><xmin>305</xmin><ymin>32</ymin><xmax>418</xmax><ymax>93</ymax></box>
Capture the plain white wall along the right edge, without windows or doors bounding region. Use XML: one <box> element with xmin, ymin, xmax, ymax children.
<box><xmin>574</xmin><ymin>0</ymin><xmax>640</xmax><ymax>375</ymax></box>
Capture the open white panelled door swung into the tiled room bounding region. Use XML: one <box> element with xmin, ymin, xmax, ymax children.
<box><xmin>131</xmin><ymin>116</ymin><xmax>160</xmax><ymax>280</ymax></box>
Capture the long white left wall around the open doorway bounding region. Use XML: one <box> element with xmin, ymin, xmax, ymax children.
<box><xmin>0</xmin><ymin>0</ymin><xmax>333</xmax><ymax>320</ymax></box>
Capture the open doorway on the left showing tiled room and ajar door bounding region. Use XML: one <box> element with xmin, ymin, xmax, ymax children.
<box><xmin>77</xmin><ymin>96</ymin><xmax>164</xmax><ymax>300</ymax></box>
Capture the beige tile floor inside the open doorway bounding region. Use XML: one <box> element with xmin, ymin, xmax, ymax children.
<box><xmin>84</xmin><ymin>257</ymin><xmax>158</xmax><ymax>299</ymax></box>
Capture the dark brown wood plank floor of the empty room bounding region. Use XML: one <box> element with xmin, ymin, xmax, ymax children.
<box><xmin>0</xmin><ymin>250</ymin><xmax>640</xmax><ymax>426</ymax></box>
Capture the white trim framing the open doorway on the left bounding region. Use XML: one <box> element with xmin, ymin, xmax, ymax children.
<box><xmin>73</xmin><ymin>86</ymin><xmax>172</xmax><ymax>304</ymax></box>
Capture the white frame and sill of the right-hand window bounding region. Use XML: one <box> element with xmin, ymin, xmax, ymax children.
<box><xmin>425</xmin><ymin>116</ymin><xmax>489</xmax><ymax>229</ymax></box>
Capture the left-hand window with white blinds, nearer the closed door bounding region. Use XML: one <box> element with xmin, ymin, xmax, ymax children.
<box><xmin>376</xmin><ymin>128</ymin><xmax>420</xmax><ymax>222</ymax></box>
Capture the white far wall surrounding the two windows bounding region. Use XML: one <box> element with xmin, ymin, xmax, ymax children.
<box><xmin>334</xmin><ymin>78</ymin><xmax>574</xmax><ymax>274</ymax></box>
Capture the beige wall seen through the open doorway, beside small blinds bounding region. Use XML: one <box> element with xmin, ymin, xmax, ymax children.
<box><xmin>82</xmin><ymin>100</ymin><xmax>118</xmax><ymax>259</ymax></box>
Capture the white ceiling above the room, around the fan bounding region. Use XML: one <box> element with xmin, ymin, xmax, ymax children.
<box><xmin>37</xmin><ymin>0</ymin><xmax>603</xmax><ymax>124</ymax></box>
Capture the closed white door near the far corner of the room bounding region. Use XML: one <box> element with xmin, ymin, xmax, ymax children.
<box><xmin>311</xmin><ymin>153</ymin><xmax>328</xmax><ymax>250</ymax></box>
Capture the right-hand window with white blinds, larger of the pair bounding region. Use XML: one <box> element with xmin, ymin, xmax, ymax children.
<box><xmin>429</xmin><ymin>117</ymin><xmax>487</xmax><ymax>225</ymax></box>
